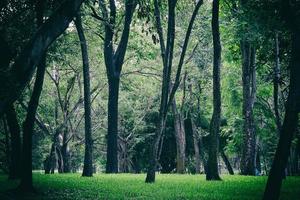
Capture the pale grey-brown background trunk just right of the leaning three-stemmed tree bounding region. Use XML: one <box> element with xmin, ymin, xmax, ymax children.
<box><xmin>172</xmin><ymin>99</ymin><xmax>186</xmax><ymax>174</ymax></box>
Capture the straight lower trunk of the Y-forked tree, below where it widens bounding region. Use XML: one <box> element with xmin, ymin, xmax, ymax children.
<box><xmin>106</xmin><ymin>78</ymin><xmax>120</xmax><ymax>173</ymax></box>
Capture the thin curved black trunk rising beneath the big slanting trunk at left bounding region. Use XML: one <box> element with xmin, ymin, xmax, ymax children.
<box><xmin>19</xmin><ymin>55</ymin><xmax>46</xmax><ymax>192</ymax></box>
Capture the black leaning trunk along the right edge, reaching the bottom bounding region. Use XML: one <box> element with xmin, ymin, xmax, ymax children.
<box><xmin>263</xmin><ymin>14</ymin><xmax>300</xmax><ymax>200</ymax></box>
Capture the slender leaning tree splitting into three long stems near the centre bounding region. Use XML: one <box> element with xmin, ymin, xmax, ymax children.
<box><xmin>146</xmin><ymin>0</ymin><xmax>203</xmax><ymax>183</ymax></box>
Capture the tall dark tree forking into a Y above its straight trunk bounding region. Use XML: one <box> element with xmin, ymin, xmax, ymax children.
<box><xmin>99</xmin><ymin>0</ymin><xmax>136</xmax><ymax>173</ymax></box>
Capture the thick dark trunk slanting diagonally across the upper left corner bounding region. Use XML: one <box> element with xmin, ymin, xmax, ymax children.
<box><xmin>0</xmin><ymin>0</ymin><xmax>84</xmax><ymax>115</ymax></box>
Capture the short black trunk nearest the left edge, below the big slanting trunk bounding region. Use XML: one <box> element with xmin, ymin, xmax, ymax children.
<box><xmin>5</xmin><ymin>105</ymin><xmax>21</xmax><ymax>179</ymax></box>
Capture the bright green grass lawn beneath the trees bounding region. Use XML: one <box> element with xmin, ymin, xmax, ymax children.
<box><xmin>0</xmin><ymin>173</ymin><xmax>300</xmax><ymax>200</ymax></box>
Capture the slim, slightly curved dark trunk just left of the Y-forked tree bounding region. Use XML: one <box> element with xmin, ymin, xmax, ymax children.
<box><xmin>75</xmin><ymin>13</ymin><xmax>93</xmax><ymax>176</ymax></box>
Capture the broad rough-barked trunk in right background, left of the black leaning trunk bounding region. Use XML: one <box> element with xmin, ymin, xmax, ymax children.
<box><xmin>241</xmin><ymin>40</ymin><xmax>256</xmax><ymax>175</ymax></box>
